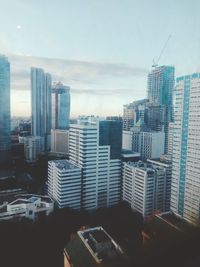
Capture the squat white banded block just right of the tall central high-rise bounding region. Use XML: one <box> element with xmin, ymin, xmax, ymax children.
<box><xmin>123</xmin><ymin>161</ymin><xmax>167</xmax><ymax>217</ymax></box>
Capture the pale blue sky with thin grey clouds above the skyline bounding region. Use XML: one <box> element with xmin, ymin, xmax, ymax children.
<box><xmin>0</xmin><ymin>0</ymin><xmax>200</xmax><ymax>117</ymax></box>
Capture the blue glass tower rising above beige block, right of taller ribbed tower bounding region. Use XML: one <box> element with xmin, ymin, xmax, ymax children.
<box><xmin>52</xmin><ymin>82</ymin><xmax>70</xmax><ymax>130</ymax></box>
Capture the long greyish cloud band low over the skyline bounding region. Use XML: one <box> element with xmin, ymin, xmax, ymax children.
<box><xmin>8</xmin><ymin>55</ymin><xmax>147</xmax><ymax>95</ymax></box>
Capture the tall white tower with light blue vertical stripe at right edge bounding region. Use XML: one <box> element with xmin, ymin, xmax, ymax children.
<box><xmin>171</xmin><ymin>73</ymin><xmax>200</xmax><ymax>224</ymax></box>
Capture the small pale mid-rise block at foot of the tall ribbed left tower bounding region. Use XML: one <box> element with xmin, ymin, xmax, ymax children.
<box><xmin>24</xmin><ymin>136</ymin><xmax>41</xmax><ymax>163</ymax></box>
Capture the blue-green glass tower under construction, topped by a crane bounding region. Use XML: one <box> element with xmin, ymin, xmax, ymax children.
<box><xmin>146</xmin><ymin>66</ymin><xmax>175</xmax><ymax>153</ymax></box>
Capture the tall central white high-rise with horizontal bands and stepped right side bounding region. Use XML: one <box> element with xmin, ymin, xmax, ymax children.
<box><xmin>69</xmin><ymin>121</ymin><xmax>121</xmax><ymax>210</ymax></box>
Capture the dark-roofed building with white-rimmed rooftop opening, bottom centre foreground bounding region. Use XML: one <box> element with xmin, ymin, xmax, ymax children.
<box><xmin>64</xmin><ymin>227</ymin><xmax>126</xmax><ymax>267</ymax></box>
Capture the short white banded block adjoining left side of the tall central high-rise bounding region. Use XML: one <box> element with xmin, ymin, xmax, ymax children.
<box><xmin>48</xmin><ymin>160</ymin><xmax>81</xmax><ymax>210</ymax></box>
